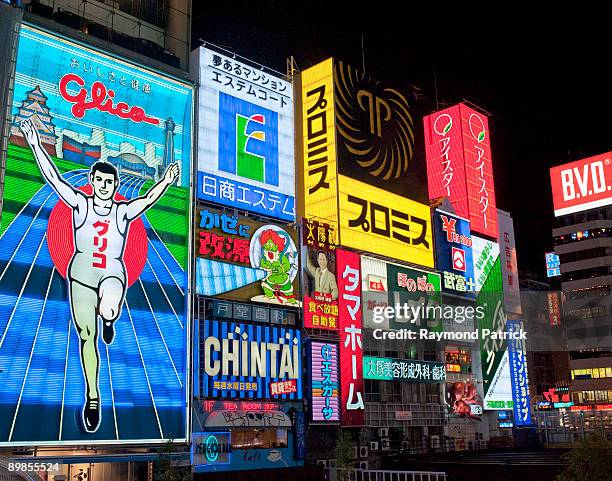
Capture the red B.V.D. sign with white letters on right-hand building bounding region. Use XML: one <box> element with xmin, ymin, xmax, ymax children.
<box><xmin>550</xmin><ymin>152</ymin><xmax>612</xmax><ymax>217</ymax></box>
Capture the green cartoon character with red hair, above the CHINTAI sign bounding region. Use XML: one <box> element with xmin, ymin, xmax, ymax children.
<box><xmin>250</xmin><ymin>225</ymin><xmax>301</xmax><ymax>306</ymax></box>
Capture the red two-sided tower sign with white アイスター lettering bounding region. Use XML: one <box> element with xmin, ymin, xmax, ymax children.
<box><xmin>423</xmin><ymin>103</ymin><xmax>497</xmax><ymax>238</ymax></box>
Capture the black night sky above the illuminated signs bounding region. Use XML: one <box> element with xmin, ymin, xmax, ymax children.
<box><xmin>192</xmin><ymin>0</ymin><xmax>612</xmax><ymax>277</ymax></box>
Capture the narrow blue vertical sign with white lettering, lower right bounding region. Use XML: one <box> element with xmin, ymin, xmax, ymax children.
<box><xmin>507</xmin><ymin>320</ymin><xmax>531</xmax><ymax>426</ymax></box>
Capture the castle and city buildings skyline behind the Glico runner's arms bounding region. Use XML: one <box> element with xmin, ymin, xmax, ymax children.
<box><xmin>10</xmin><ymin>86</ymin><xmax>176</xmax><ymax>180</ymax></box>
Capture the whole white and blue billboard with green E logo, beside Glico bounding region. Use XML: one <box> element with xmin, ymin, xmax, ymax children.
<box><xmin>191</xmin><ymin>48</ymin><xmax>295</xmax><ymax>221</ymax></box>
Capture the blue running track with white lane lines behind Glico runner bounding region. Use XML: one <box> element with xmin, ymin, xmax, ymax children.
<box><xmin>0</xmin><ymin>170</ymin><xmax>188</xmax><ymax>445</ymax></box>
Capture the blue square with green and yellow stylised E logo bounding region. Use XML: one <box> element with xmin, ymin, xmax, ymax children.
<box><xmin>219</xmin><ymin>92</ymin><xmax>279</xmax><ymax>186</ymax></box>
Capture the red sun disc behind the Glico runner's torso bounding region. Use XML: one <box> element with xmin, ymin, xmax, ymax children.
<box><xmin>47</xmin><ymin>184</ymin><xmax>148</xmax><ymax>287</ymax></box>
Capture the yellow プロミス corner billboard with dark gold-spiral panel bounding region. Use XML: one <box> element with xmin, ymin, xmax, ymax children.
<box><xmin>298</xmin><ymin>59</ymin><xmax>434</xmax><ymax>267</ymax></box>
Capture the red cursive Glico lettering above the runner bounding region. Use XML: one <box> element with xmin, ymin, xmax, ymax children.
<box><xmin>59</xmin><ymin>73</ymin><xmax>159</xmax><ymax>125</ymax></box>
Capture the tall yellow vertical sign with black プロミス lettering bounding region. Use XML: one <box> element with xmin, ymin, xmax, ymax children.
<box><xmin>300</xmin><ymin>58</ymin><xmax>338</xmax><ymax>232</ymax></box>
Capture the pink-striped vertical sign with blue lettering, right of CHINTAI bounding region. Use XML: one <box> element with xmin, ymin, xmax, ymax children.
<box><xmin>310</xmin><ymin>341</ymin><xmax>340</xmax><ymax>422</ymax></box>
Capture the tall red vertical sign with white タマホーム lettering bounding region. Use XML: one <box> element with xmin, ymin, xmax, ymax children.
<box><xmin>336</xmin><ymin>250</ymin><xmax>365</xmax><ymax>426</ymax></box>
